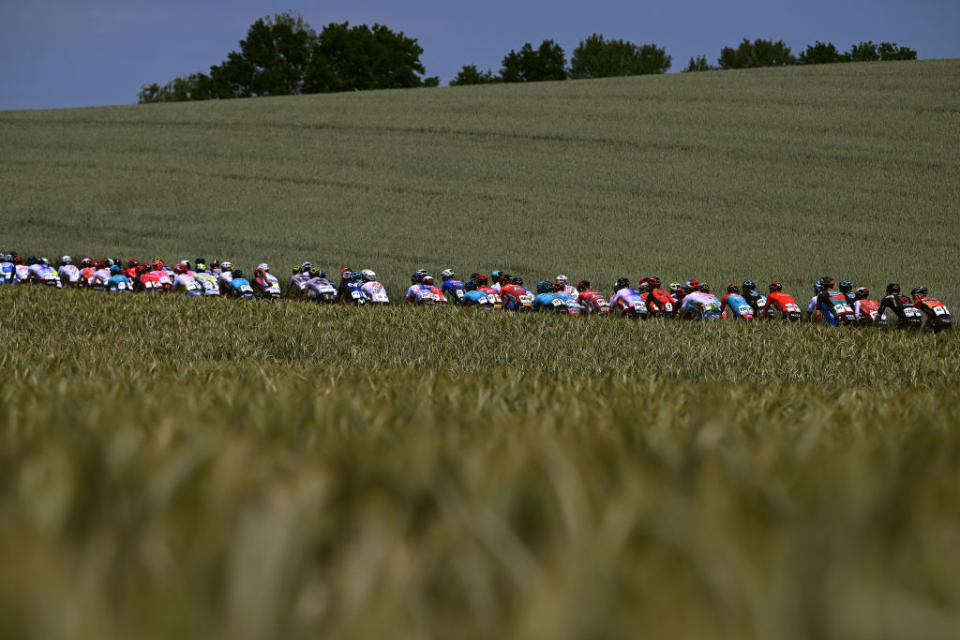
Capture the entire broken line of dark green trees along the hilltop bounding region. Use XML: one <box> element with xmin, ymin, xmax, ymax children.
<box><xmin>138</xmin><ymin>13</ymin><xmax>917</xmax><ymax>104</ymax></box>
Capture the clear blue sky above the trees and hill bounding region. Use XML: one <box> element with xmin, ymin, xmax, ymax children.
<box><xmin>0</xmin><ymin>0</ymin><xmax>960</xmax><ymax>109</ymax></box>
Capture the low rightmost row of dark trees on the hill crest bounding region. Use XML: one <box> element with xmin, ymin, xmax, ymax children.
<box><xmin>684</xmin><ymin>38</ymin><xmax>917</xmax><ymax>71</ymax></box>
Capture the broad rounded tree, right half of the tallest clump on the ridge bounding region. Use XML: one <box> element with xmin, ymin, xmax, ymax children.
<box><xmin>304</xmin><ymin>22</ymin><xmax>439</xmax><ymax>93</ymax></box>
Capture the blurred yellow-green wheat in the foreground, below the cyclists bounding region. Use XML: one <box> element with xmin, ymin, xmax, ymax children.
<box><xmin>0</xmin><ymin>287</ymin><xmax>960</xmax><ymax>639</ymax></box>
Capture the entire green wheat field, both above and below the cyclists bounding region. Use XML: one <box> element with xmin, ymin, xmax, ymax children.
<box><xmin>0</xmin><ymin>60</ymin><xmax>960</xmax><ymax>640</ymax></box>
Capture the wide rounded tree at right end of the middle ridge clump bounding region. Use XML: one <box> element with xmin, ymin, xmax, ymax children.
<box><xmin>569</xmin><ymin>33</ymin><xmax>670</xmax><ymax>78</ymax></box>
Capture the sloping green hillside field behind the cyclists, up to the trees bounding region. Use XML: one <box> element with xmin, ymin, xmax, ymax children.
<box><xmin>0</xmin><ymin>60</ymin><xmax>960</xmax><ymax>300</ymax></box>
